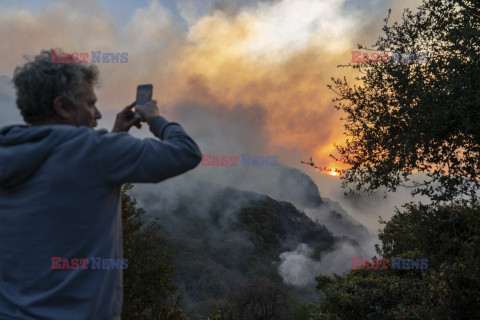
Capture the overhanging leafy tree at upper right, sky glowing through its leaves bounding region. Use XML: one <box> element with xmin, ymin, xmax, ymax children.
<box><xmin>329</xmin><ymin>0</ymin><xmax>480</xmax><ymax>201</ymax></box>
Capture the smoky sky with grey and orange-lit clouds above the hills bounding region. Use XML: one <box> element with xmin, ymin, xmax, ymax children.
<box><xmin>0</xmin><ymin>0</ymin><xmax>426</xmax><ymax>230</ymax></box>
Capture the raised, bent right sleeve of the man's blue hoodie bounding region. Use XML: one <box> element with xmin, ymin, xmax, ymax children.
<box><xmin>95</xmin><ymin>116</ymin><xmax>202</xmax><ymax>185</ymax></box>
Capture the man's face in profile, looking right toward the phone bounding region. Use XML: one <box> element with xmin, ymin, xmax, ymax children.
<box><xmin>71</xmin><ymin>81</ymin><xmax>102</xmax><ymax>128</ymax></box>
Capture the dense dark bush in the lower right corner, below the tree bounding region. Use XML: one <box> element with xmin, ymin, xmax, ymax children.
<box><xmin>313</xmin><ymin>201</ymin><xmax>480</xmax><ymax>319</ymax></box>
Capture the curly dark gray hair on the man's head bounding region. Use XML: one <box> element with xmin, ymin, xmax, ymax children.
<box><xmin>13</xmin><ymin>49</ymin><xmax>98</xmax><ymax>124</ymax></box>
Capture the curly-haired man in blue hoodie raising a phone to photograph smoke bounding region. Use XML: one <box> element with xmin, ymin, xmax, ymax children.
<box><xmin>0</xmin><ymin>51</ymin><xmax>202</xmax><ymax>320</ymax></box>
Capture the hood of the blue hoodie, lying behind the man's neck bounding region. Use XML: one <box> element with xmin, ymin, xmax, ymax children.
<box><xmin>0</xmin><ymin>125</ymin><xmax>75</xmax><ymax>188</ymax></box>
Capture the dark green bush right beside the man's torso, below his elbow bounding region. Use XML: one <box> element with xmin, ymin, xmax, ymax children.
<box><xmin>122</xmin><ymin>184</ymin><xmax>188</xmax><ymax>320</ymax></box>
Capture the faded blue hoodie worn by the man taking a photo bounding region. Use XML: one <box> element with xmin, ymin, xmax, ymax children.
<box><xmin>0</xmin><ymin>116</ymin><xmax>202</xmax><ymax>320</ymax></box>
